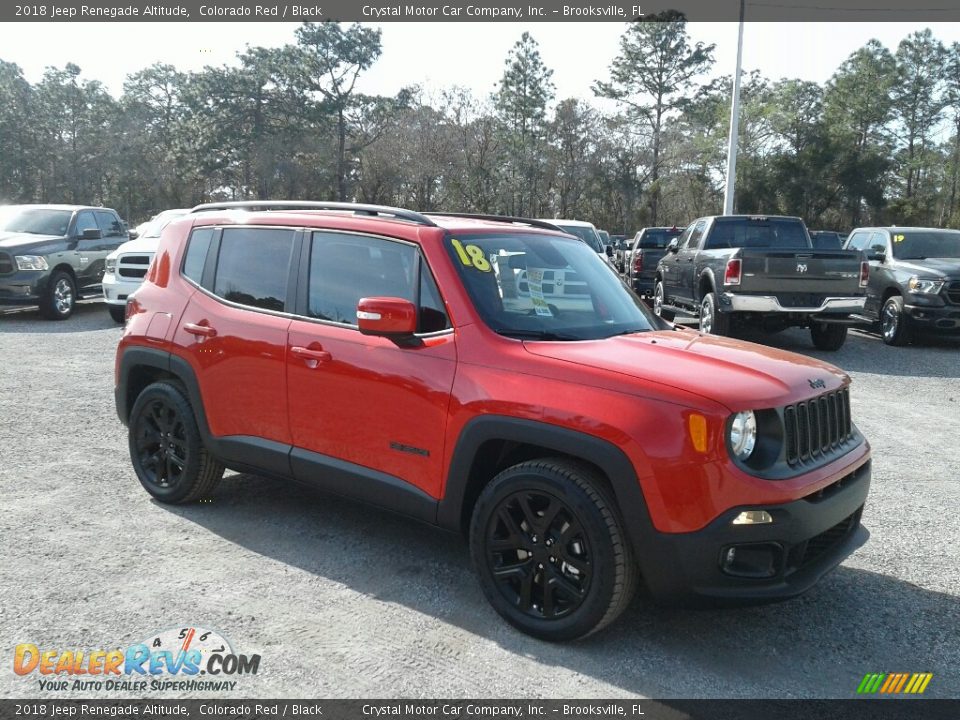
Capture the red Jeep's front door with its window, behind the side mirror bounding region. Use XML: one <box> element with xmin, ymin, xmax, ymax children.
<box><xmin>287</xmin><ymin>231</ymin><xmax>456</xmax><ymax>498</ymax></box>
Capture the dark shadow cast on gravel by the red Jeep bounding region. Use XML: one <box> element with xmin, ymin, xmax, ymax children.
<box><xmin>158</xmin><ymin>475</ymin><xmax>960</xmax><ymax>699</ymax></box>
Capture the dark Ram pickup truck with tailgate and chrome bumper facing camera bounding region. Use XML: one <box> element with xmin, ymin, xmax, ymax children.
<box><xmin>654</xmin><ymin>215</ymin><xmax>869</xmax><ymax>350</ymax></box>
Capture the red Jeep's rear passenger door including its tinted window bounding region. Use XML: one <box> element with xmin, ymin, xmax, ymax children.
<box><xmin>174</xmin><ymin>226</ymin><xmax>300</xmax><ymax>450</ymax></box>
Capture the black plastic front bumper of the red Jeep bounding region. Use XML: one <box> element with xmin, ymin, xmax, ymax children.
<box><xmin>641</xmin><ymin>461</ymin><xmax>870</xmax><ymax>606</ymax></box>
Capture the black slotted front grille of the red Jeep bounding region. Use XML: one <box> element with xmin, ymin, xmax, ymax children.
<box><xmin>783</xmin><ymin>388</ymin><xmax>853</xmax><ymax>465</ymax></box>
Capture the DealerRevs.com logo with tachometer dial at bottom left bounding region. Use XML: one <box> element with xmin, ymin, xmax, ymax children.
<box><xmin>13</xmin><ymin>626</ymin><xmax>260</xmax><ymax>692</ymax></box>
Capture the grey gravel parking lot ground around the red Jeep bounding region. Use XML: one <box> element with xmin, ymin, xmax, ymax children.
<box><xmin>0</xmin><ymin>302</ymin><xmax>960</xmax><ymax>698</ymax></box>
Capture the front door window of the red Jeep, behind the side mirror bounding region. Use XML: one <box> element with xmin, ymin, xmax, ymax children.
<box><xmin>307</xmin><ymin>232</ymin><xmax>412</xmax><ymax>325</ymax></box>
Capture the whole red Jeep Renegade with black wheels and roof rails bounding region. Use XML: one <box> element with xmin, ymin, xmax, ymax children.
<box><xmin>116</xmin><ymin>202</ymin><xmax>870</xmax><ymax>640</ymax></box>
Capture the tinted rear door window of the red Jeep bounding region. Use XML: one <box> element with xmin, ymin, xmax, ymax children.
<box><xmin>213</xmin><ymin>228</ymin><xmax>294</xmax><ymax>310</ymax></box>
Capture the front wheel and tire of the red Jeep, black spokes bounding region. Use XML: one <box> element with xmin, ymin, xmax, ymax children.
<box><xmin>470</xmin><ymin>458</ymin><xmax>639</xmax><ymax>642</ymax></box>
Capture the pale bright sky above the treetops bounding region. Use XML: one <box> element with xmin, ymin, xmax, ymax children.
<box><xmin>0</xmin><ymin>22</ymin><xmax>960</xmax><ymax>100</ymax></box>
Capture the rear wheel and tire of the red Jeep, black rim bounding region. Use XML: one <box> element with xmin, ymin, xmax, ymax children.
<box><xmin>128</xmin><ymin>382</ymin><xmax>224</xmax><ymax>504</ymax></box>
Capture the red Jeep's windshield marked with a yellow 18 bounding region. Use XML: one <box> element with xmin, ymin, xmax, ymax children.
<box><xmin>445</xmin><ymin>233</ymin><xmax>658</xmax><ymax>340</ymax></box>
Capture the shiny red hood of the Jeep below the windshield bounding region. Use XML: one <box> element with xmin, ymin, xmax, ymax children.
<box><xmin>524</xmin><ymin>330</ymin><xmax>849</xmax><ymax>411</ymax></box>
